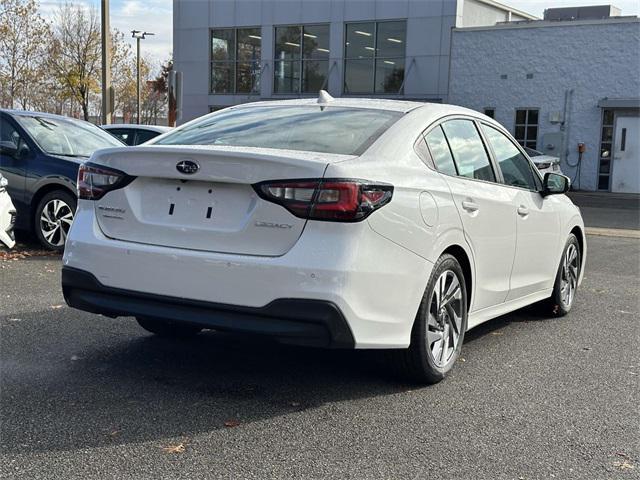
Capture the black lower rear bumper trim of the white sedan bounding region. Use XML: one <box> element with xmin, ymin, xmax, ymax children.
<box><xmin>62</xmin><ymin>267</ymin><xmax>355</xmax><ymax>348</ymax></box>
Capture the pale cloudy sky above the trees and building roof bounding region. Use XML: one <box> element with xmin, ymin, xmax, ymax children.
<box><xmin>40</xmin><ymin>0</ymin><xmax>640</xmax><ymax>66</ymax></box>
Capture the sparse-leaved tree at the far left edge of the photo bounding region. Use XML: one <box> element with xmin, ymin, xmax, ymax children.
<box><xmin>0</xmin><ymin>0</ymin><xmax>51</xmax><ymax>109</ymax></box>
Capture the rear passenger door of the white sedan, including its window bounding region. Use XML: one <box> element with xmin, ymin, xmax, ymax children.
<box><xmin>426</xmin><ymin>118</ymin><xmax>516</xmax><ymax>311</ymax></box>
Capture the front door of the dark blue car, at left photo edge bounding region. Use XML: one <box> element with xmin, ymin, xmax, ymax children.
<box><xmin>0</xmin><ymin>115</ymin><xmax>28</xmax><ymax>211</ymax></box>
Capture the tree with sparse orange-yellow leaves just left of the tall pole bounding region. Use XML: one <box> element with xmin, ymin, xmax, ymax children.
<box><xmin>48</xmin><ymin>3</ymin><xmax>101</xmax><ymax>120</ymax></box>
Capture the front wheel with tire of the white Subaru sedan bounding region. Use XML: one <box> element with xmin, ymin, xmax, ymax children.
<box><xmin>542</xmin><ymin>233</ymin><xmax>582</xmax><ymax>317</ymax></box>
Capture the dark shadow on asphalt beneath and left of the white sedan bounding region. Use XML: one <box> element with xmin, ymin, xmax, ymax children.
<box><xmin>0</xmin><ymin>319</ymin><xmax>412</xmax><ymax>454</ymax></box>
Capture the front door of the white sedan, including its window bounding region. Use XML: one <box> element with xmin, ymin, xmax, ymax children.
<box><xmin>482</xmin><ymin>124</ymin><xmax>560</xmax><ymax>301</ymax></box>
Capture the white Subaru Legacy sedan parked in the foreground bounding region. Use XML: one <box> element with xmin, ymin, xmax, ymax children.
<box><xmin>62</xmin><ymin>92</ymin><xmax>586</xmax><ymax>382</ymax></box>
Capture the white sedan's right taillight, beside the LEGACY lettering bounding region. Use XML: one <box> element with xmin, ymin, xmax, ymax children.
<box><xmin>253</xmin><ymin>178</ymin><xmax>393</xmax><ymax>222</ymax></box>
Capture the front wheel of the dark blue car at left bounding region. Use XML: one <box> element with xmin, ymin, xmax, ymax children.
<box><xmin>33</xmin><ymin>190</ymin><xmax>78</xmax><ymax>252</ymax></box>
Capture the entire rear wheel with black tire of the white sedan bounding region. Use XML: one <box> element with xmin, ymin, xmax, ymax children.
<box><xmin>390</xmin><ymin>254</ymin><xmax>467</xmax><ymax>384</ymax></box>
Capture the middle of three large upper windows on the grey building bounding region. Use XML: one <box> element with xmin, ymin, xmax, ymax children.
<box><xmin>273</xmin><ymin>24</ymin><xmax>329</xmax><ymax>93</ymax></box>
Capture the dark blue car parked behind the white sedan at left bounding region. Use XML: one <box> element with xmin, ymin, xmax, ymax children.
<box><xmin>0</xmin><ymin>110</ymin><xmax>123</xmax><ymax>251</ymax></box>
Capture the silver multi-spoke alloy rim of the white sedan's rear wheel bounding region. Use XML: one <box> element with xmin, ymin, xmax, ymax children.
<box><xmin>427</xmin><ymin>270</ymin><xmax>463</xmax><ymax>368</ymax></box>
